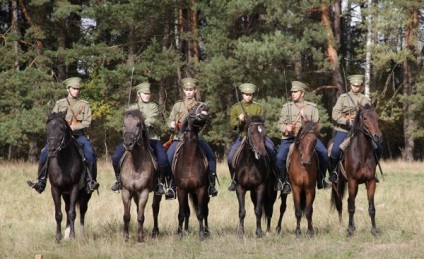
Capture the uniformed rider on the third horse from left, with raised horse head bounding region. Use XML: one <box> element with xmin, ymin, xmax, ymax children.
<box><xmin>165</xmin><ymin>78</ymin><xmax>218</xmax><ymax>199</ymax></box>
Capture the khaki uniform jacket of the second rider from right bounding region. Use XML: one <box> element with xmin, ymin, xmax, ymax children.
<box><xmin>278</xmin><ymin>101</ymin><xmax>319</xmax><ymax>139</ymax></box>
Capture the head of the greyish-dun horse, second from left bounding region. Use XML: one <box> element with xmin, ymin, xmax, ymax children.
<box><xmin>123</xmin><ymin>110</ymin><xmax>147</xmax><ymax>151</ymax></box>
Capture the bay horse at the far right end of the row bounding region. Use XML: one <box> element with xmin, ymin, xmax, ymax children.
<box><xmin>331</xmin><ymin>103</ymin><xmax>382</xmax><ymax>237</ymax></box>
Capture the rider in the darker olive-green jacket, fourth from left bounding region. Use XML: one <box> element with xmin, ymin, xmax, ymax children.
<box><xmin>227</xmin><ymin>83</ymin><xmax>283</xmax><ymax>191</ymax></box>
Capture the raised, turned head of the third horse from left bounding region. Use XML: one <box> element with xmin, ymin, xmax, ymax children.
<box><xmin>181</xmin><ymin>102</ymin><xmax>209</xmax><ymax>133</ymax></box>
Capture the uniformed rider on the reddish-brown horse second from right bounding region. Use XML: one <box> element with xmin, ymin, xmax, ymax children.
<box><xmin>277</xmin><ymin>81</ymin><xmax>331</xmax><ymax>193</ymax></box>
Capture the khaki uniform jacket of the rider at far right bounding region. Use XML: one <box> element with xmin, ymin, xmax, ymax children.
<box><xmin>331</xmin><ymin>91</ymin><xmax>370</xmax><ymax>132</ymax></box>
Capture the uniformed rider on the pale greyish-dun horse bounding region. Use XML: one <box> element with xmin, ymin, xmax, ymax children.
<box><xmin>110</xmin><ymin>82</ymin><xmax>169</xmax><ymax>195</ymax></box>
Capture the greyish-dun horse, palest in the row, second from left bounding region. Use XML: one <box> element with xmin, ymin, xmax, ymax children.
<box><xmin>121</xmin><ymin>110</ymin><xmax>162</xmax><ymax>242</ymax></box>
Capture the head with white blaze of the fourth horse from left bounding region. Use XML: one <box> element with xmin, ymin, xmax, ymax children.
<box><xmin>246</xmin><ymin>116</ymin><xmax>267</xmax><ymax>159</ymax></box>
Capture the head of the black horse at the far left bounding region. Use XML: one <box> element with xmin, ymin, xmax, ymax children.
<box><xmin>46</xmin><ymin>110</ymin><xmax>72</xmax><ymax>157</ymax></box>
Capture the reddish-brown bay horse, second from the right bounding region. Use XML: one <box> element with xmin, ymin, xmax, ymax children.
<box><xmin>277</xmin><ymin>117</ymin><xmax>319</xmax><ymax>238</ymax></box>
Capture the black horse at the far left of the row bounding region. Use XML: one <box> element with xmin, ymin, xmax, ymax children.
<box><xmin>46</xmin><ymin>110</ymin><xmax>91</xmax><ymax>242</ymax></box>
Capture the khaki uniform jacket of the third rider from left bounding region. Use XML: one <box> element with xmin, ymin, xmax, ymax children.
<box><xmin>168</xmin><ymin>98</ymin><xmax>201</xmax><ymax>140</ymax></box>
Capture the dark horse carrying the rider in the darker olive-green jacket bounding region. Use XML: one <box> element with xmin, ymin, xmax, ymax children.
<box><xmin>233</xmin><ymin>116</ymin><xmax>277</xmax><ymax>238</ymax></box>
